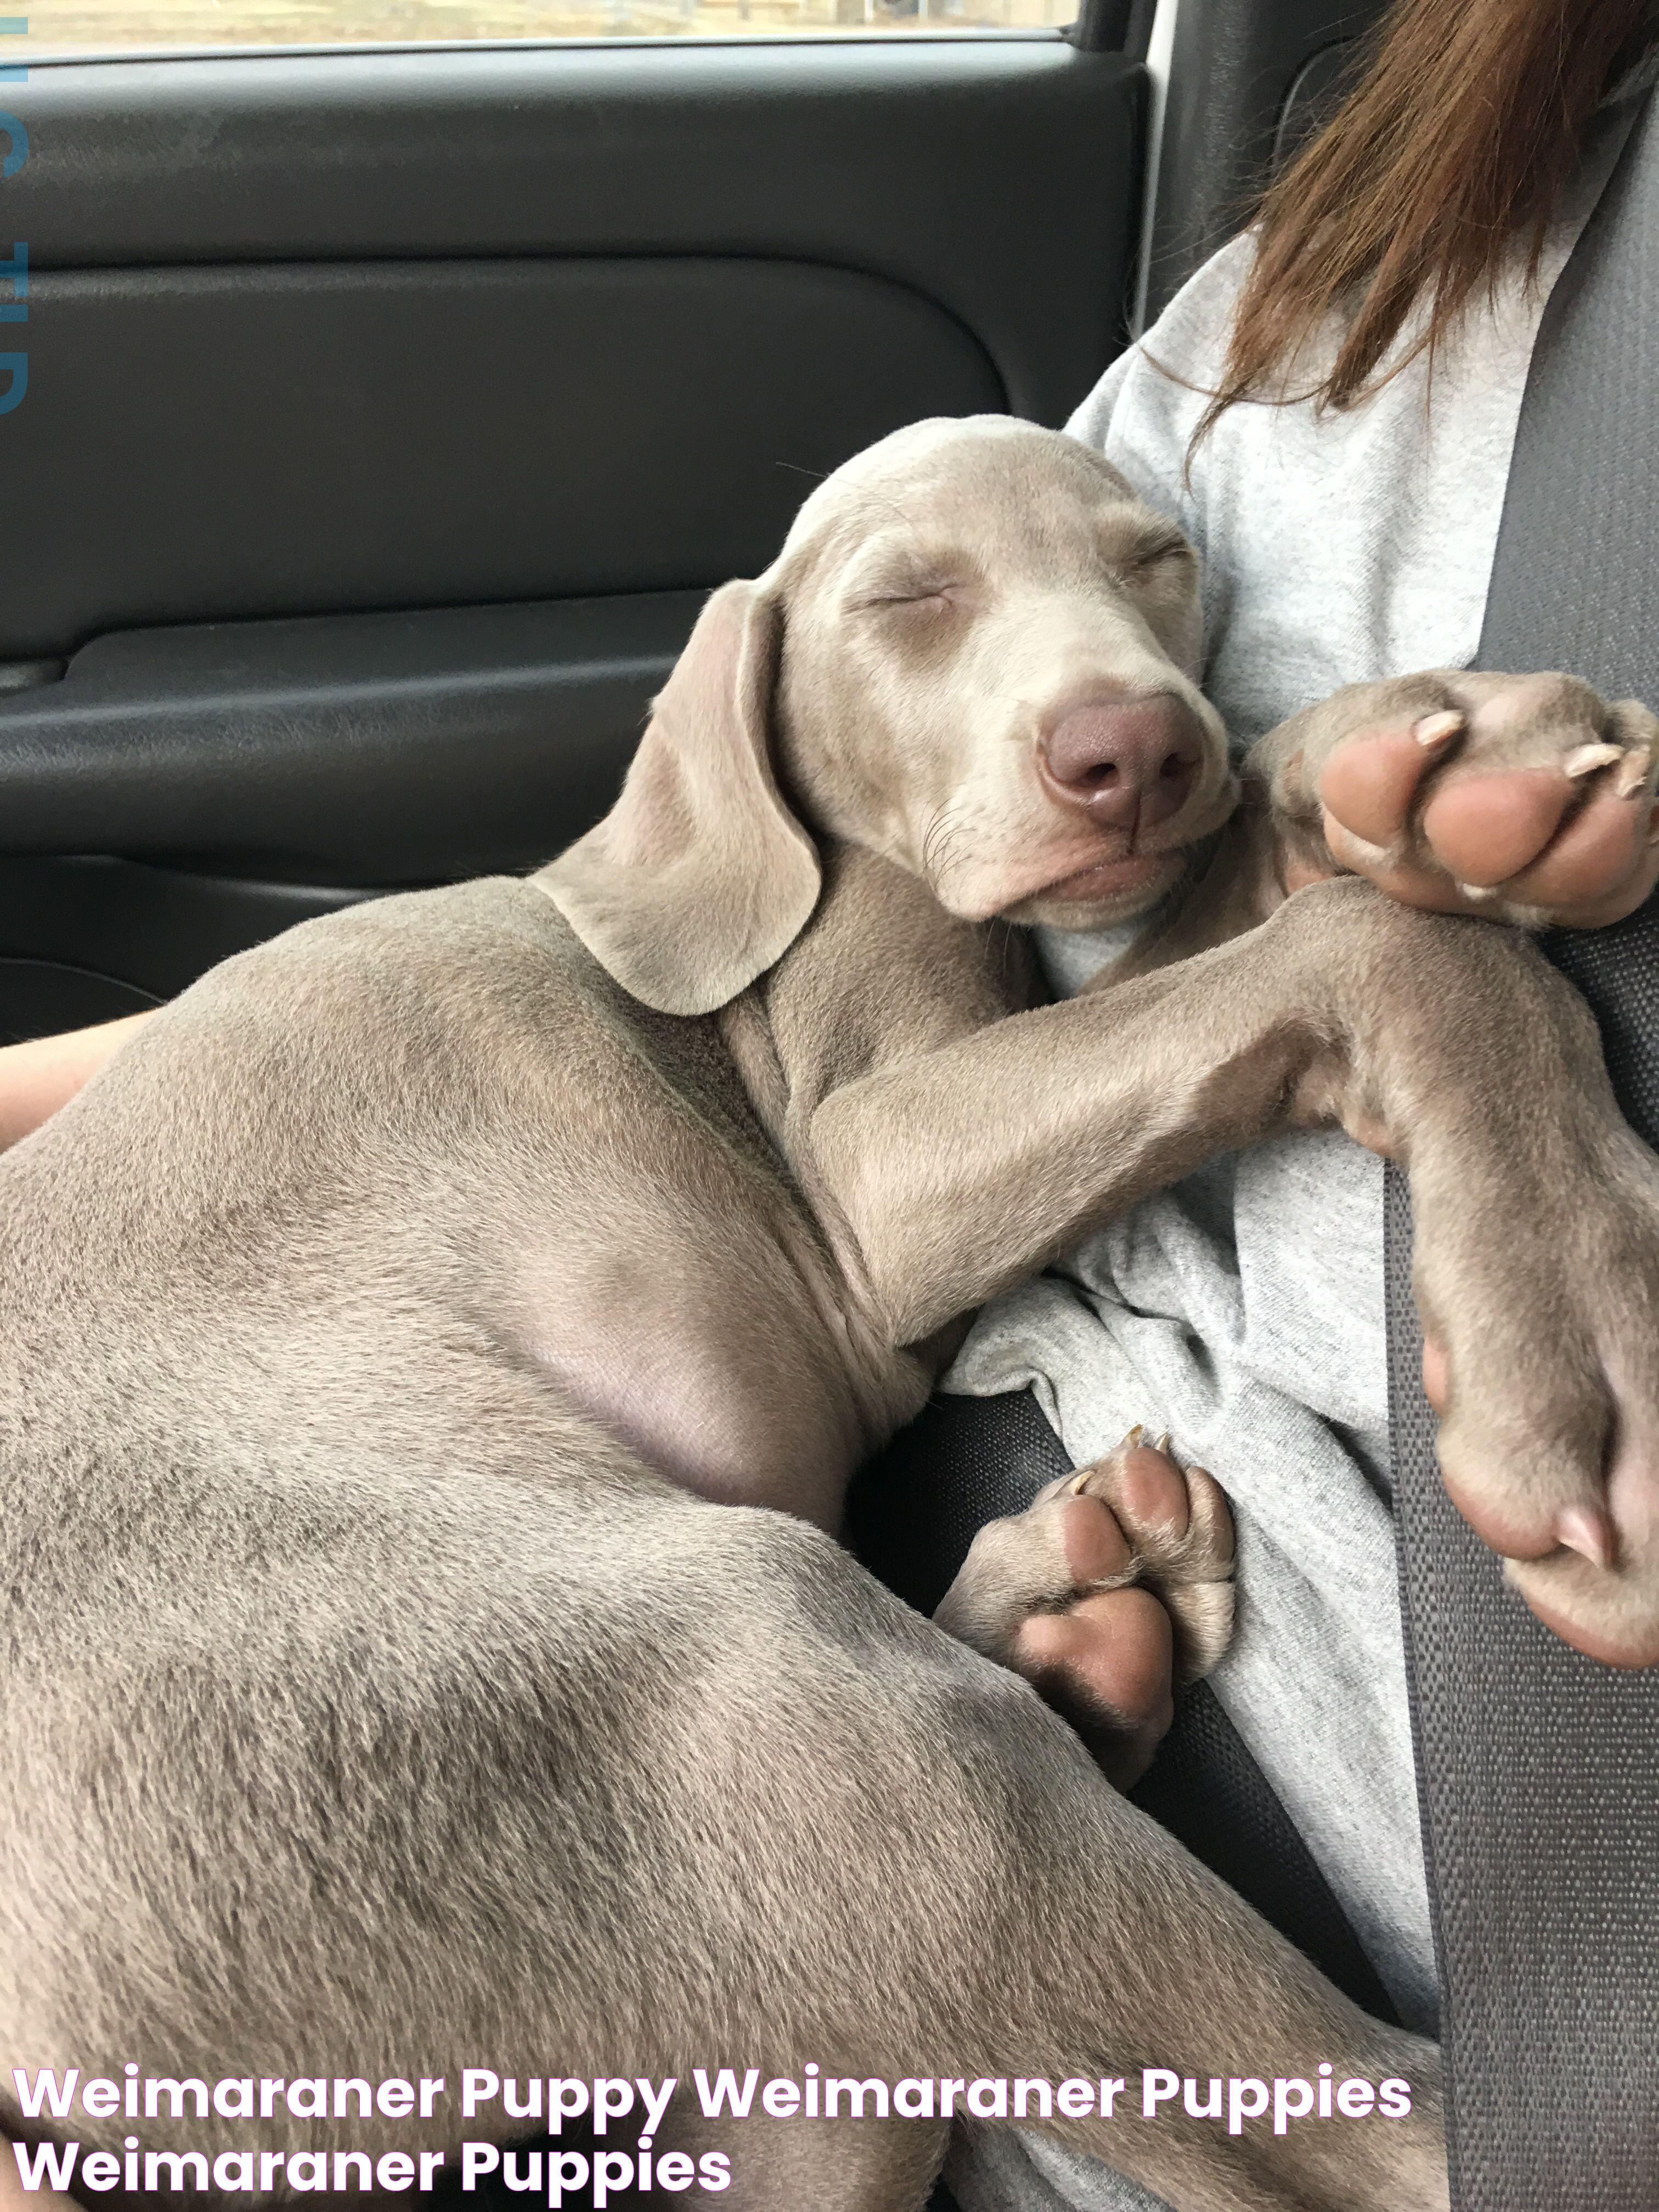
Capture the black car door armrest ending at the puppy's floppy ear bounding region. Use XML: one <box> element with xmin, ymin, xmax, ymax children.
<box><xmin>0</xmin><ymin>591</ymin><xmax>703</xmax><ymax>887</ymax></box>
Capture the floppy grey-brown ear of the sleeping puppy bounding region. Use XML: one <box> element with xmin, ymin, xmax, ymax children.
<box><xmin>533</xmin><ymin>584</ymin><xmax>821</xmax><ymax>1013</ymax></box>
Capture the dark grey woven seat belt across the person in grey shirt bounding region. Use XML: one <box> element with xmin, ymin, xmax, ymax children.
<box><xmin>1387</xmin><ymin>86</ymin><xmax>1659</xmax><ymax>2212</ymax></box>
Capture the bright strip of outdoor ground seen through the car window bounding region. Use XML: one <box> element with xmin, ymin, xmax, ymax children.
<box><xmin>0</xmin><ymin>0</ymin><xmax>1077</xmax><ymax>62</ymax></box>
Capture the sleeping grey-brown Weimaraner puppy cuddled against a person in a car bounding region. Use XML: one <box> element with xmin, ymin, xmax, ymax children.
<box><xmin>0</xmin><ymin>420</ymin><xmax>1659</xmax><ymax>2212</ymax></box>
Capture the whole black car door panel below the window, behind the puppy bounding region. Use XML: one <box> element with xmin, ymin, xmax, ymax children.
<box><xmin>0</xmin><ymin>36</ymin><xmax>1146</xmax><ymax>1033</ymax></box>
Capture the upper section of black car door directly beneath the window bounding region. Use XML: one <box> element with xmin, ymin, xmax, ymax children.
<box><xmin>7</xmin><ymin>36</ymin><xmax>1146</xmax><ymax>420</ymax></box>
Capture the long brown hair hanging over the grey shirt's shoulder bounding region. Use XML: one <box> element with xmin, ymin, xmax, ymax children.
<box><xmin>1194</xmin><ymin>0</ymin><xmax>1659</xmax><ymax>442</ymax></box>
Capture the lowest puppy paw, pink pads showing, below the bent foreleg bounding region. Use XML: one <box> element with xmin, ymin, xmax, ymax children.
<box><xmin>936</xmin><ymin>1429</ymin><xmax>1232</xmax><ymax>1790</ymax></box>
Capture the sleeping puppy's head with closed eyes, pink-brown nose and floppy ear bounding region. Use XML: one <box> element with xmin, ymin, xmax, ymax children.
<box><xmin>540</xmin><ymin>416</ymin><xmax>1239</xmax><ymax>1013</ymax></box>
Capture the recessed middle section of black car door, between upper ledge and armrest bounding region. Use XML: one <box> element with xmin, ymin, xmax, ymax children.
<box><xmin>13</xmin><ymin>255</ymin><xmax>1009</xmax><ymax>657</ymax></box>
